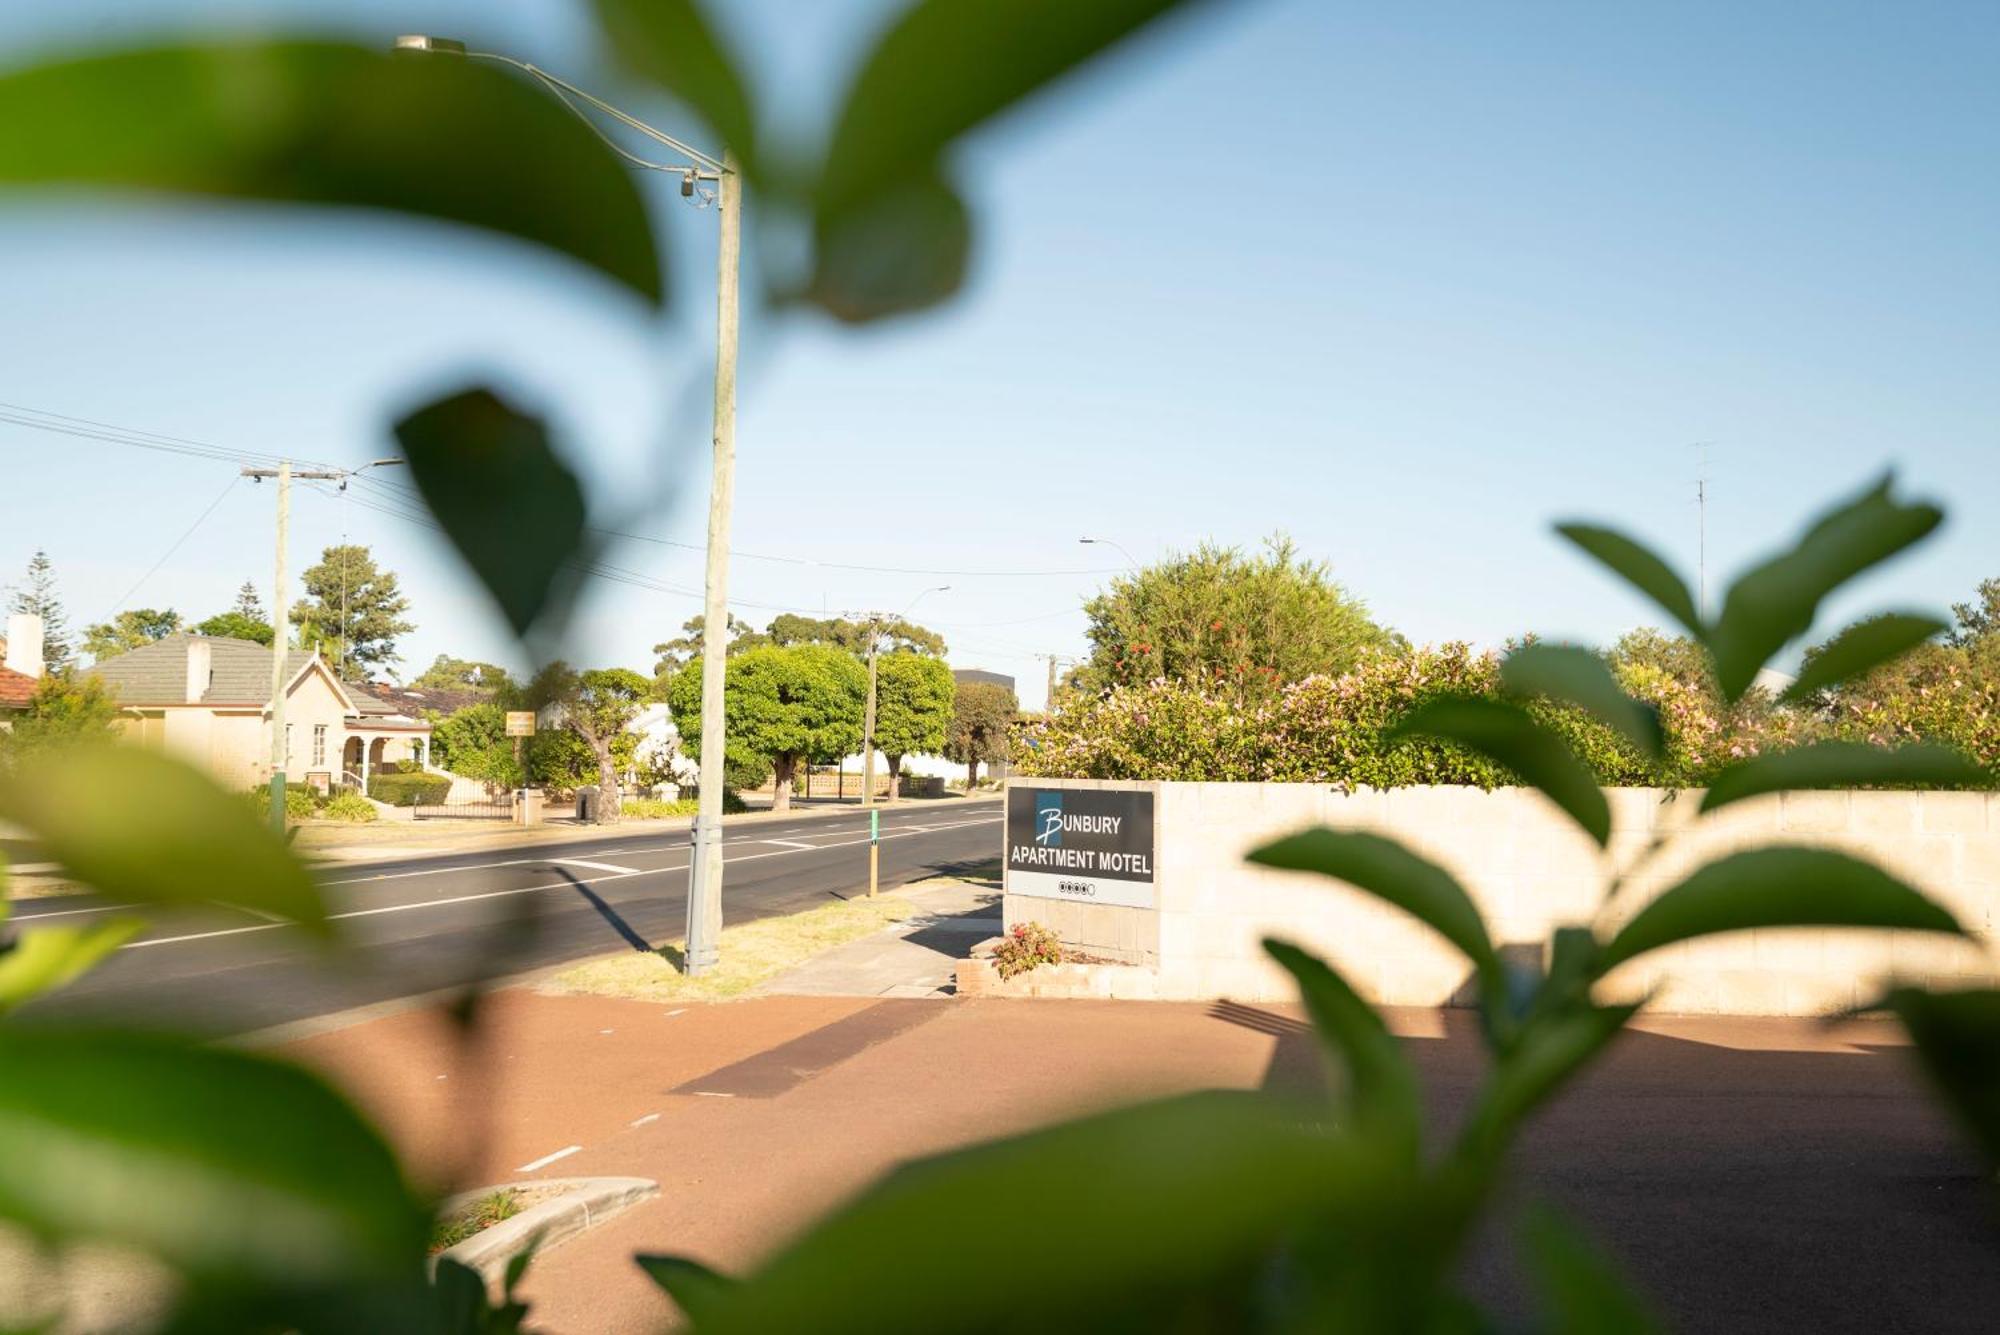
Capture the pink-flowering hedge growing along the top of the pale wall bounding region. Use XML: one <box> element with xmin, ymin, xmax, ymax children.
<box><xmin>1014</xmin><ymin>644</ymin><xmax>2000</xmax><ymax>791</ymax></box>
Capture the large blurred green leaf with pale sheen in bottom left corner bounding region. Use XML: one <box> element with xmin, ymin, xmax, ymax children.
<box><xmin>0</xmin><ymin>1027</ymin><xmax>428</xmax><ymax>1289</ymax></box>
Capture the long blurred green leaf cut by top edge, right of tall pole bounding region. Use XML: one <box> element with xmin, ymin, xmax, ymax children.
<box><xmin>820</xmin><ymin>0</ymin><xmax>1216</xmax><ymax>216</ymax></box>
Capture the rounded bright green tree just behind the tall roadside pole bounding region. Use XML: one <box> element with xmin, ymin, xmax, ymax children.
<box><xmin>668</xmin><ymin>644</ymin><xmax>868</xmax><ymax>811</ymax></box>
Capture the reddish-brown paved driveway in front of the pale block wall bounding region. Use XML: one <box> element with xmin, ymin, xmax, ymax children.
<box><xmin>288</xmin><ymin>979</ymin><xmax>2000</xmax><ymax>1333</ymax></box>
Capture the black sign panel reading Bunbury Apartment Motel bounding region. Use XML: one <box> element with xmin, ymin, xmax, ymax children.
<box><xmin>1006</xmin><ymin>787</ymin><xmax>1154</xmax><ymax>907</ymax></box>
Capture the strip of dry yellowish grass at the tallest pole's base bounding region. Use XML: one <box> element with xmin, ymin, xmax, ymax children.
<box><xmin>542</xmin><ymin>895</ymin><xmax>922</xmax><ymax>1001</ymax></box>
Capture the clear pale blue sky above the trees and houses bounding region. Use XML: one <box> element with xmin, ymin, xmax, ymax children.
<box><xmin>0</xmin><ymin>0</ymin><xmax>2000</xmax><ymax>703</ymax></box>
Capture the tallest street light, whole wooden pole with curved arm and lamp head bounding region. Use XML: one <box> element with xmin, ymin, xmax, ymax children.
<box><xmin>396</xmin><ymin>34</ymin><xmax>742</xmax><ymax>975</ymax></box>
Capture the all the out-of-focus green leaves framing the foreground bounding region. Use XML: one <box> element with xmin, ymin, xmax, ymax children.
<box><xmin>0</xmin><ymin>10</ymin><xmax>2000</xmax><ymax>1335</ymax></box>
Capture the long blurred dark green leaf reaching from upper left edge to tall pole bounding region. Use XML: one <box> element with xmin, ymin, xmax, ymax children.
<box><xmin>0</xmin><ymin>40</ymin><xmax>664</xmax><ymax>302</ymax></box>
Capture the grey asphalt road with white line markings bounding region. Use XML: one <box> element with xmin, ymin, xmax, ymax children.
<box><xmin>0</xmin><ymin>803</ymin><xmax>1000</xmax><ymax>1035</ymax></box>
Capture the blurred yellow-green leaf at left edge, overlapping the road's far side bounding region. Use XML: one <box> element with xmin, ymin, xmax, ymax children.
<box><xmin>0</xmin><ymin>745</ymin><xmax>332</xmax><ymax>935</ymax></box>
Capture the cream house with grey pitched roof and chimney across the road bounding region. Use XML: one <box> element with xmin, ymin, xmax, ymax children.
<box><xmin>90</xmin><ymin>634</ymin><xmax>430</xmax><ymax>789</ymax></box>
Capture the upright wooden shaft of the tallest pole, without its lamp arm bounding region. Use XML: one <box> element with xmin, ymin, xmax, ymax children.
<box><xmin>688</xmin><ymin>150</ymin><xmax>742</xmax><ymax>977</ymax></box>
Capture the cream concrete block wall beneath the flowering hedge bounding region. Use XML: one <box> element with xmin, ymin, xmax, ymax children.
<box><xmin>1006</xmin><ymin>779</ymin><xmax>2000</xmax><ymax>1015</ymax></box>
